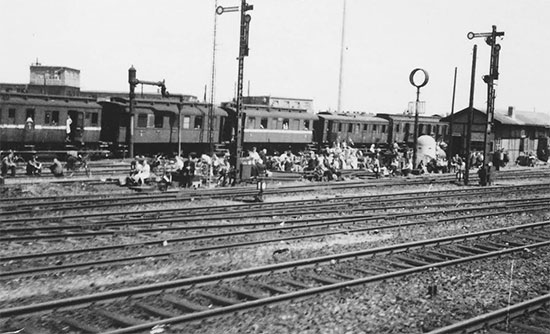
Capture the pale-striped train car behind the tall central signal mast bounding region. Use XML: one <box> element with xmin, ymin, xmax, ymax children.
<box><xmin>222</xmin><ymin>99</ymin><xmax>317</xmax><ymax>152</ymax></box>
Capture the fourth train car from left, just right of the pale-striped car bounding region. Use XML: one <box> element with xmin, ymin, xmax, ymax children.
<box><xmin>314</xmin><ymin>112</ymin><xmax>389</xmax><ymax>147</ymax></box>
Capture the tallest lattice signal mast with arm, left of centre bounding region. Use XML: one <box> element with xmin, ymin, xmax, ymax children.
<box><xmin>216</xmin><ymin>0</ymin><xmax>254</xmax><ymax>175</ymax></box>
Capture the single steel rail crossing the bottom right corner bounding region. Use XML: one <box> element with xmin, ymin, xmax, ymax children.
<box><xmin>428</xmin><ymin>294</ymin><xmax>550</xmax><ymax>334</ymax></box>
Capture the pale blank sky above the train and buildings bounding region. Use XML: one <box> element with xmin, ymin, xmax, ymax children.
<box><xmin>0</xmin><ymin>0</ymin><xmax>550</xmax><ymax>114</ymax></box>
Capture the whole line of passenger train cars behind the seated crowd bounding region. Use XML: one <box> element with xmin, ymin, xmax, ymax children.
<box><xmin>0</xmin><ymin>92</ymin><xmax>447</xmax><ymax>154</ymax></box>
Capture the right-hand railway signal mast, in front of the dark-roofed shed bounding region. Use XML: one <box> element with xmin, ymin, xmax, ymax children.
<box><xmin>467</xmin><ymin>25</ymin><xmax>504</xmax><ymax>166</ymax></box>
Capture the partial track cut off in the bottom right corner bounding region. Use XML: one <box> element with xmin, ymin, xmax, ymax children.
<box><xmin>428</xmin><ymin>294</ymin><xmax>550</xmax><ymax>334</ymax></box>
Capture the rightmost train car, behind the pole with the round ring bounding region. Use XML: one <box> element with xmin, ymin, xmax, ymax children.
<box><xmin>376</xmin><ymin>114</ymin><xmax>449</xmax><ymax>147</ymax></box>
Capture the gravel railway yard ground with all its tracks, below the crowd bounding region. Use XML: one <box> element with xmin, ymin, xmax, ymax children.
<box><xmin>0</xmin><ymin>162</ymin><xmax>550</xmax><ymax>334</ymax></box>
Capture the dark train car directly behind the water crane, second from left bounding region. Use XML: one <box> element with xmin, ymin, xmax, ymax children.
<box><xmin>99</xmin><ymin>97</ymin><xmax>227</xmax><ymax>154</ymax></box>
